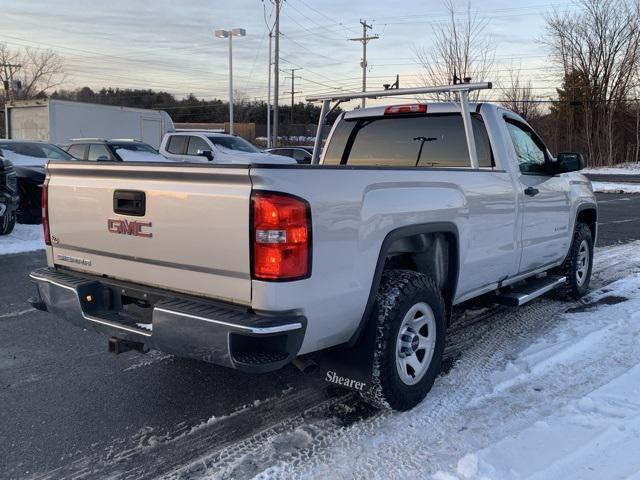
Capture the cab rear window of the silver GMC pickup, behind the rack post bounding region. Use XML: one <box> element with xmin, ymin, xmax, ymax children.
<box><xmin>324</xmin><ymin>113</ymin><xmax>494</xmax><ymax>168</ymax></box>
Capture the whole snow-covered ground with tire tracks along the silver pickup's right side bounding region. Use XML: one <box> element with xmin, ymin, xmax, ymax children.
<box><xmin>169</xmin><ymin>242</ymin><xmax>640</xmax><ymax>480</ymax></box>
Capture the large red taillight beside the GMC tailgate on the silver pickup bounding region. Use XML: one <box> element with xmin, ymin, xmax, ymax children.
<box><xmin>251</xmin><ymin>192</ymin><xmax>311</xmax><ymax>280</ymax></box>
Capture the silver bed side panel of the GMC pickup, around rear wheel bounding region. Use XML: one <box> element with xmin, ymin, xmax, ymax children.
<box><xmin>251</xmin><ymin>167</ymin><xmax>520</xmax><ymax>353</ymax></box>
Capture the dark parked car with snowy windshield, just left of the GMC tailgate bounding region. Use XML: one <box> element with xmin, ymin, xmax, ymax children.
<box><xmin>0</xmin><ymin>140</ymin><xmax>73</xmax><ymax>223</ymax></box>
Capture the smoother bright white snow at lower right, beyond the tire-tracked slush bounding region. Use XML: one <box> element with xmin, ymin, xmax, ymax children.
<box><xmin>433</xmin><ymin>274</ymin><xmax>640</xmax><ymax>480</ymax></box>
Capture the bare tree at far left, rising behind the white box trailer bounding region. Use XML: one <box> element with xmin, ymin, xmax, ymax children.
<box><xmin>0</xmin><ymin>43</ymin><xmax>64</xmax><ymax>99</ymax></box>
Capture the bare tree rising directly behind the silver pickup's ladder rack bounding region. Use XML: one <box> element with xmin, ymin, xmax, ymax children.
<box><xmin>416</xmin><ymin>0</ymin><xmax>495</xmax><ymax>99</ymax></box>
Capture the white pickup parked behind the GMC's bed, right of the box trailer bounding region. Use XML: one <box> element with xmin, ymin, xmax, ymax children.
<box><xmin>160</xmin><ymin>131</ymin><xmax>295</xmax><ymax>165</ymax></box>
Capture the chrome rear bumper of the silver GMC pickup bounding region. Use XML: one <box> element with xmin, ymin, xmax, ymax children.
<box><xmin>30</xmin><ymin>268</ymin><xmax>306</xmax><ymax>372</ymax></box>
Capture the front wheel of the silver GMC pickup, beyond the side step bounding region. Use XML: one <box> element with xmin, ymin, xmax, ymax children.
<box><xmin>550</xmin><ymin>223</ymin><xmax>593</xmax><ymax>300</ymax></box>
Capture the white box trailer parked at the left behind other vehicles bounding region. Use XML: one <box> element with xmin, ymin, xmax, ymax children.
<box><xmin>5</xmin><ymin>99</ymin><xmax>174</xmax><ymax>148</ymax></box>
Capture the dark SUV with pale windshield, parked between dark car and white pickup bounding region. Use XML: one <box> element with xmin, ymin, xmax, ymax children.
<box><xmin>65</xmin><ymin>138</ymin><xmax>169</xmax><ymax>162</ymax></box>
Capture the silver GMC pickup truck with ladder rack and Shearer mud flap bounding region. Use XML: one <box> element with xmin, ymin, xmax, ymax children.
<box><xmin>31</xmin><ymin>84</ymin><xmax>597</xmax><ymax>410</ymax></box>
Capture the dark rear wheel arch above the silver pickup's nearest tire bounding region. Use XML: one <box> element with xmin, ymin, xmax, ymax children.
<box><xmin>348</xmin><ymin>222</ymin><xmax>460</xmax><ymax>346</ymax></box>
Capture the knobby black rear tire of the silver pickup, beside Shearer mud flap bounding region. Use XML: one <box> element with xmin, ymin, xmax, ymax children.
<box><xmin>362</xmin><ymin>270</ymin><xmax>446</xmax><ymax>411</ymax></box>
